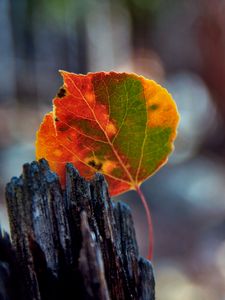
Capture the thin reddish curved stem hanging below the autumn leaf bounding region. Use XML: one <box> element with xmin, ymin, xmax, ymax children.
<box><xmin>135</xmin><ymin>186</ymin><xmax>154</xmax><ymax>260</ymax></box>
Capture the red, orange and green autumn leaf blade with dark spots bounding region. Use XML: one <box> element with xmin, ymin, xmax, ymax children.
<box><xmin>36</xmin><ymin>71</ymin><xmax>179</xmax><ymax>195</ymax></box>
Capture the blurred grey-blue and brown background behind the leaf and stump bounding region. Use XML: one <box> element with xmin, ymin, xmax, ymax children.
<box><xmin>0</xmin><ymin>0</ymin><xmax>225</xmax><ymax>300</ymax></box>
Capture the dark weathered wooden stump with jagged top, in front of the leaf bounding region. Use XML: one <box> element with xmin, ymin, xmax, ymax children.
<box><xmin>3</xmin><ymin>160</ymin><xmax>154</xmax><ymax>300</ymax></box>
